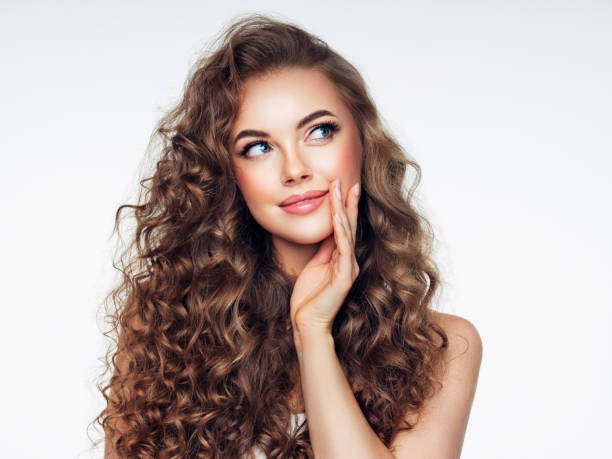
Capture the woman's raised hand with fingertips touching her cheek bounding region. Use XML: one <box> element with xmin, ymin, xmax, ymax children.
<box><xmin>290</xmin><ymin>179</ymin><xmax>359</xmax><ymax>334</ymax></box>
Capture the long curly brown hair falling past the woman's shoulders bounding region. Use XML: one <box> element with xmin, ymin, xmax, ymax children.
<box><xmin>87</xmin><ymin>14</ymin><xmax>448</xmax><ymax>459</ymax></box>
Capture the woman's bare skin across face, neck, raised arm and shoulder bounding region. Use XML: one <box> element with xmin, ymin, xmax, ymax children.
<box><xmin>105</xmin><ymin>69</ymin><xmax>482</xmax><ymax>459</ymax></box>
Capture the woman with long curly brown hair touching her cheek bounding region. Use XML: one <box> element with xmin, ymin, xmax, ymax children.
<box><xmin>96</xmin><ymin>15</ymin><xmax>482</xmax><ymax>458</ymax></box>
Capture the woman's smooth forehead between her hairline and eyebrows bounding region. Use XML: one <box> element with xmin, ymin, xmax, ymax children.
<box><xmin>232</xmin><ymin>68</ymin><xmax>349</xmax><ymax>134</ymax></box>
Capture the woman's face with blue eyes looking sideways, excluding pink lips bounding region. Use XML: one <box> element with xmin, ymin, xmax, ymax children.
<box><xmin>230</xmin><ymin>68</ymin><xmax>362</xmax><ymax>248</ymax></box>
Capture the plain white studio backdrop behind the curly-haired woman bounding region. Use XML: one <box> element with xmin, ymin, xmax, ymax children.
<box><xmin>0</xmin><ymin>0</ymin><xmax>612</xmax><ymax>459</ymax></box>
